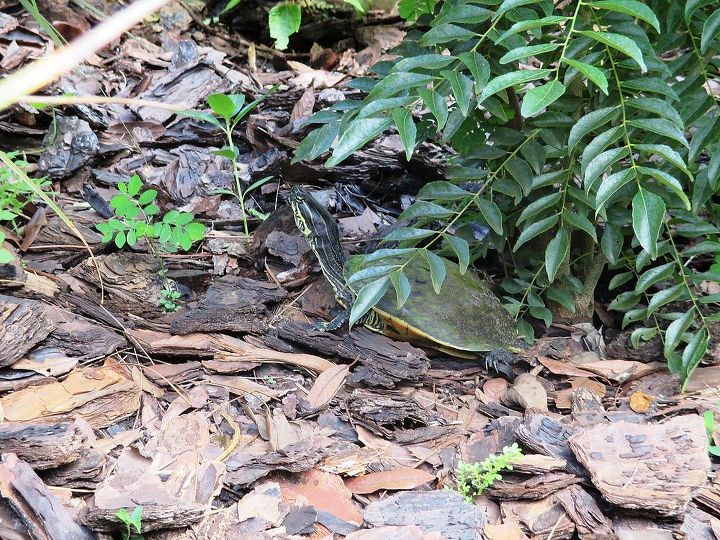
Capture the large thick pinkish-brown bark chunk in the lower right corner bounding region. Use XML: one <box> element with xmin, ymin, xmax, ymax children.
<box><xmin>569</xmin><ymin>415</ymin><xmax>710</xmax><ymax>516</ymax></box>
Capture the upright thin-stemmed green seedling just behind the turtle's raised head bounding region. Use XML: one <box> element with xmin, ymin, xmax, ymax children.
<box><xmin>180</xmin><ymin>89</ymin><xmax>277</xmax><ymax>234</ymax></box>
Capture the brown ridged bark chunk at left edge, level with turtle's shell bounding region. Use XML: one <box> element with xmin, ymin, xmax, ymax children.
<box><xmin>0</xmin><ymin>295</ymin><xmax>54</xmax><ymax>367</ymax></box>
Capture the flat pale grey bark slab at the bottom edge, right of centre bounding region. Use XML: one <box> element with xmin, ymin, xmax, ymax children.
<box><xmin>363</xmin><ymin>491</ymin><xmax>487</xmax><ymax>540</ymax></box>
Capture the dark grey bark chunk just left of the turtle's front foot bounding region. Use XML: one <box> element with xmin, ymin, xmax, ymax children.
<box><xmin>170</xmin><ymin>276</ymin><xmax>287</xmax><ymax>335</ymax></box>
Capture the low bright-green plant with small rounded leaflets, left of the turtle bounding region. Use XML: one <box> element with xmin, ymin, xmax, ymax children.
<box><xmin>96</xmin><ymin>175</ymin><xmax>205</xmax><ymax>252</ymax></box>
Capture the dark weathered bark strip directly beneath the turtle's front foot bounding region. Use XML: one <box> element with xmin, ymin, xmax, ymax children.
<box><xmin>277</xmin><ymin>321</ymin><xmax>430</xmax><ymax>388</ymax></box>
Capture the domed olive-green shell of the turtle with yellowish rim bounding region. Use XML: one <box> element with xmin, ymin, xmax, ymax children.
<box><xmin>346</xmin><ymin>257</ymin><xmax>516</xmax><ymax>356</ymax></box>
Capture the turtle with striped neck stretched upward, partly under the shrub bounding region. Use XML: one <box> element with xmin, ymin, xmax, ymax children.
<box><xmin>290</xmin><ymin>186</ymin><xmax>517</xmax><ymax>358</ymax></box>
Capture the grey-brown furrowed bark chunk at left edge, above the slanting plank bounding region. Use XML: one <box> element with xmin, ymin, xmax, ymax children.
<box><xmin>0</xmin><ymin>418</ymin><xmax>95</xmax><ymax>469</ymax></box>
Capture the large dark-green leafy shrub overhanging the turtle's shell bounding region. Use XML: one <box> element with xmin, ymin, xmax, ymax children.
<box><xmin>294</xmin><ymin>0</ymin><xmax>720</xmax><ymax>384</ymax></box>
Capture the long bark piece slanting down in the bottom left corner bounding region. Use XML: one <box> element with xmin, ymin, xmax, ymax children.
<box><xmin>0</xmin><ymin>454</ymin><xmax>94</xmax><ymax>540</ymax></box>
